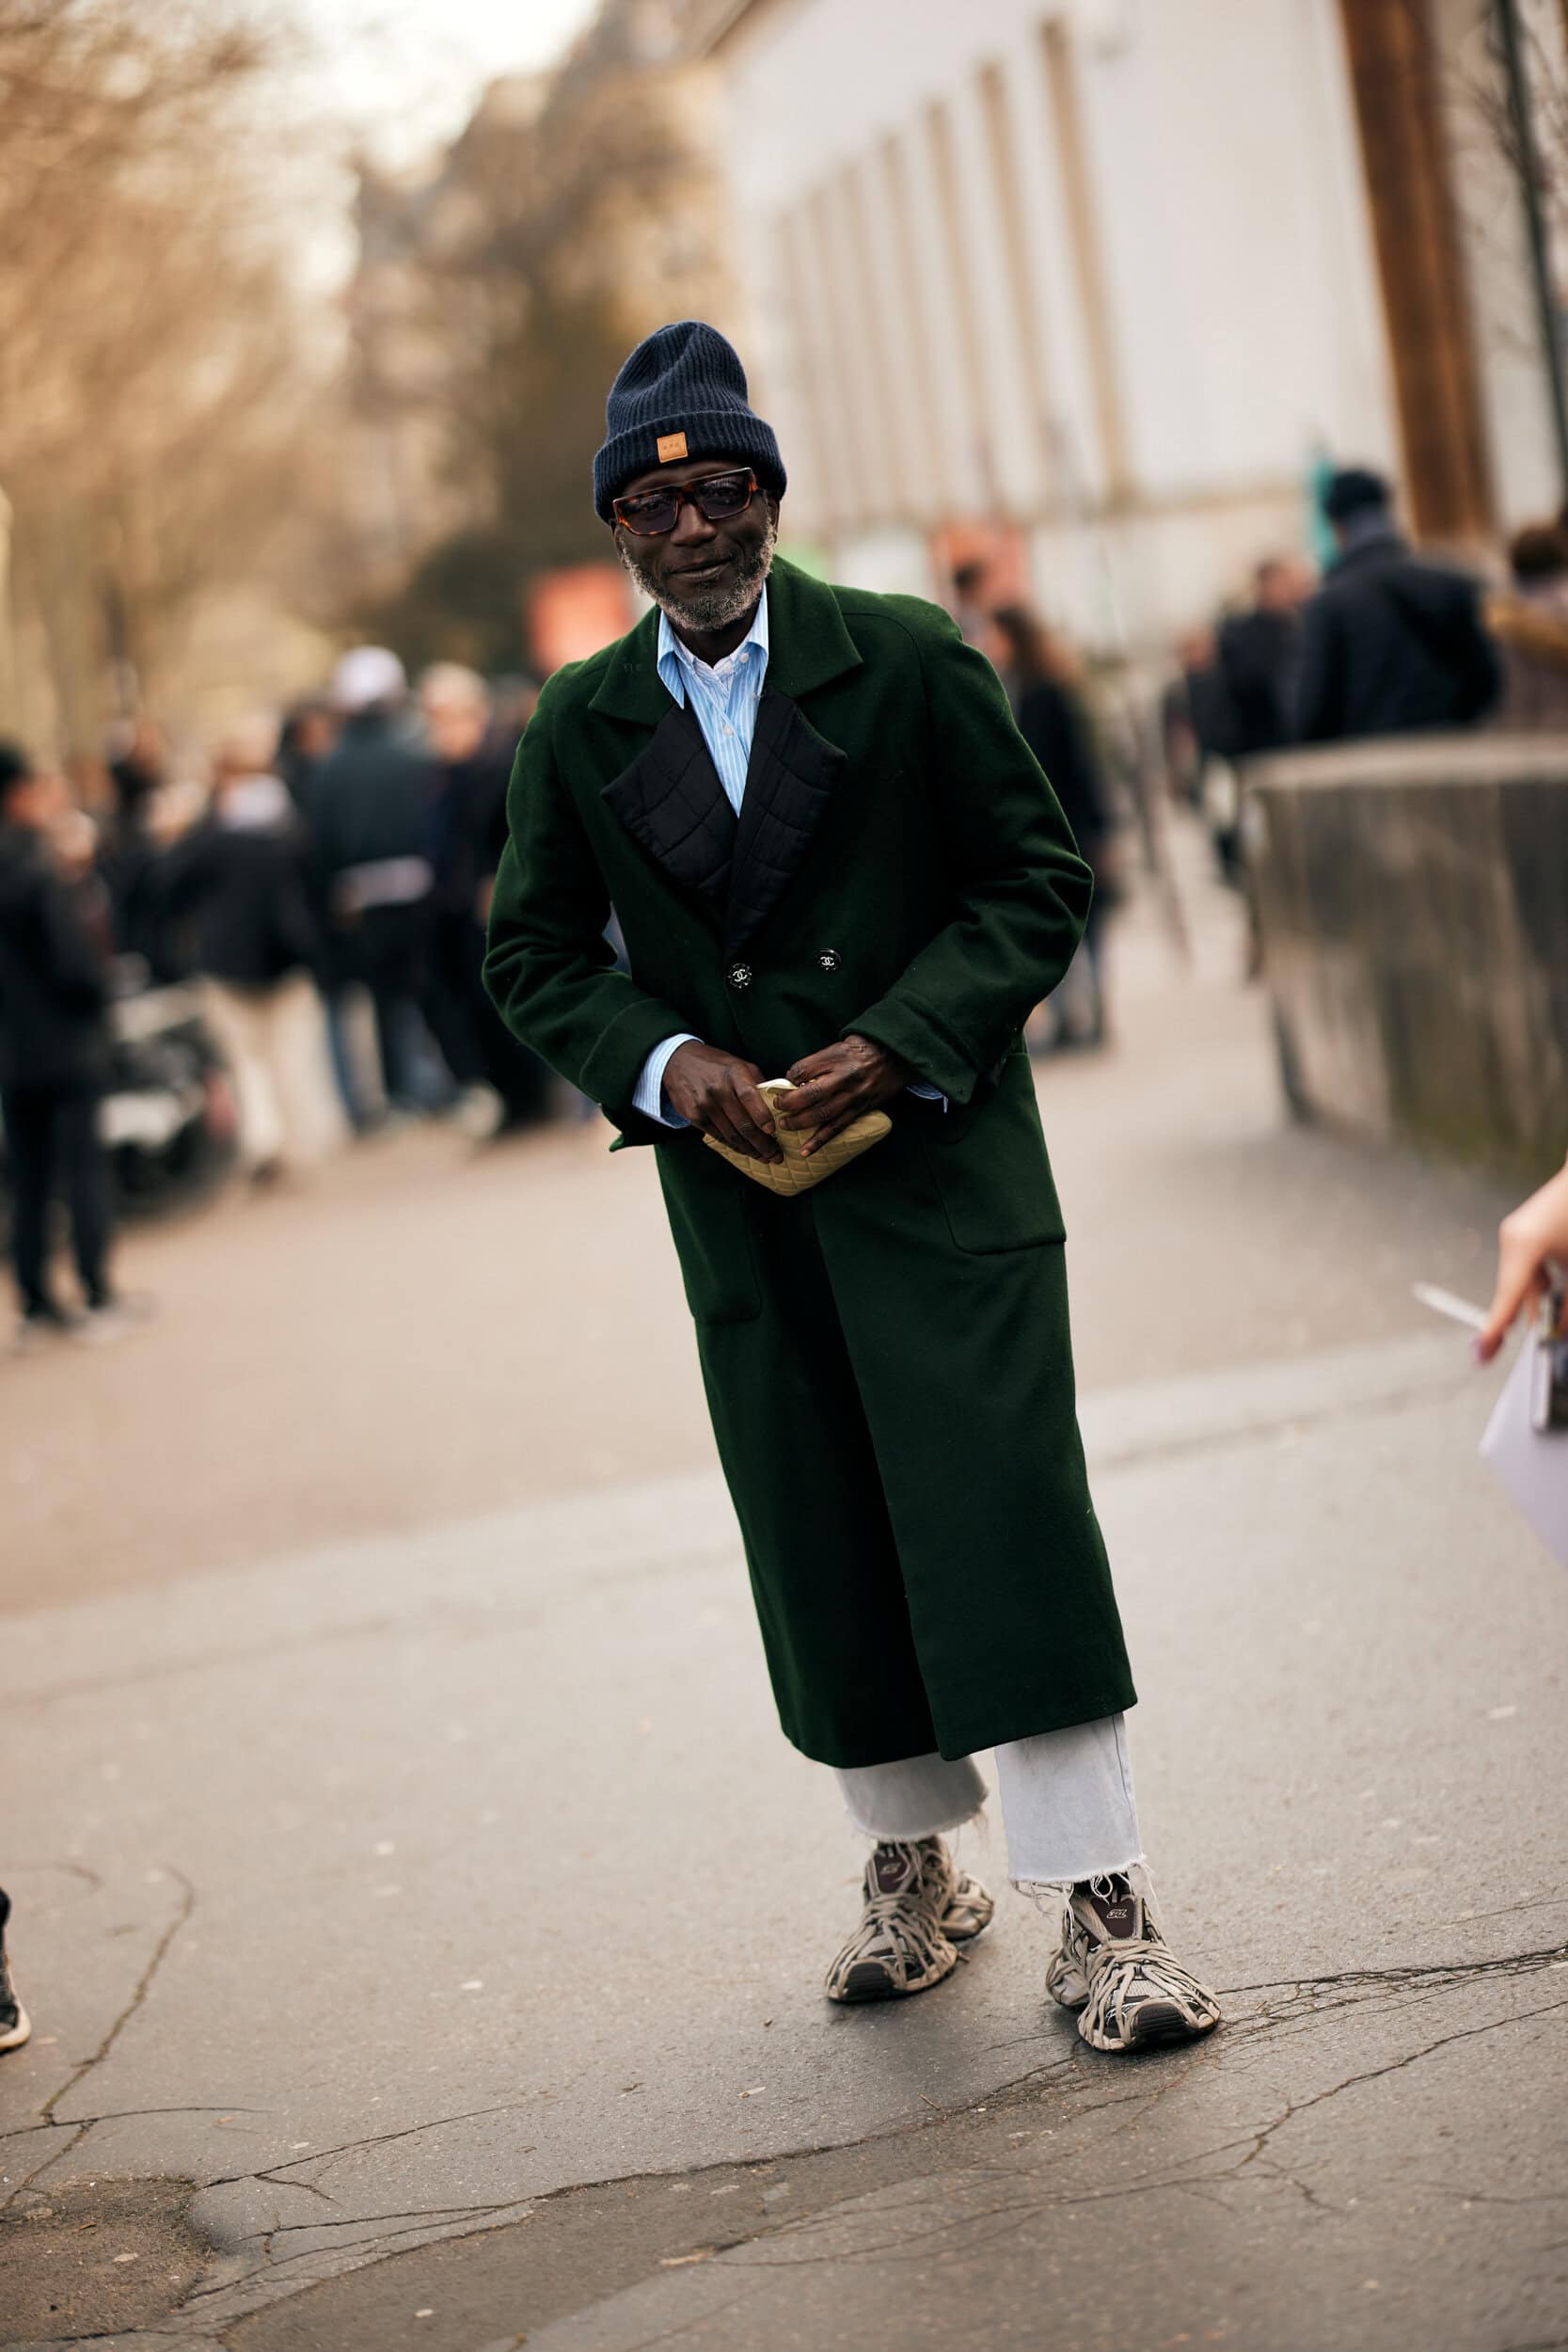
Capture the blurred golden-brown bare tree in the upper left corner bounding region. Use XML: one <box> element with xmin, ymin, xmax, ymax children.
<box><xmin>0</xmin><ymin>0</ymin><xmax>331</xmax><ymax>743</ymax></box>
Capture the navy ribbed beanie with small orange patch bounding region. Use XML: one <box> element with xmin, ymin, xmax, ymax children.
<box><xmin>593</xmin><ymin>318</ymin><xmax>785</xmax><ymax>522</ymax></box>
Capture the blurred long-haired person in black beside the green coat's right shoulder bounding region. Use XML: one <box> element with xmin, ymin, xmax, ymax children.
<box><xmin>992</xmin><ymin>605</ymin><xmax>1117</xmax><ymax>1044</ymax></box>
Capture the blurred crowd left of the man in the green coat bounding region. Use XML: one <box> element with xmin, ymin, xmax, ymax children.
<box><xmin>0</xmin><ymin>644</ymin><xmax>552</xmax><ymax>1339</ymax></box>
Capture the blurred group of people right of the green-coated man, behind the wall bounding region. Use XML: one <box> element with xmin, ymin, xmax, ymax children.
<box><xmin>950</xmin><ymin>466</ymin><xmax>1568</xmax><ymax>1052</ymax></box>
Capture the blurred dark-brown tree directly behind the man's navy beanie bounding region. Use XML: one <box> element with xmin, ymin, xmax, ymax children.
<box><xmin>341</xmin><ymin>0</ymin><xmax>724</xmax><ymax>668</ymax></box>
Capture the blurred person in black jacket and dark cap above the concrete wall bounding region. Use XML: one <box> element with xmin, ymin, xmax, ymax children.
<box><xmin>1295</xmin><ymin>466</ymin><xmax>1500</xmax><ymax>743</ymax></box>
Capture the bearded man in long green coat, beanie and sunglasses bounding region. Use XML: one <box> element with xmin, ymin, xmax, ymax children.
<box><xmin>484</xmin><ymin>320</ymin><xmax>1218</xmax><ymax>2051</ymax></box>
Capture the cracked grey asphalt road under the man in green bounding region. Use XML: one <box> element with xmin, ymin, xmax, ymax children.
<box><xmin>0</xmin><ymin>847</ymin><xmax>1568</xmax><ymax>2352</ymax></box>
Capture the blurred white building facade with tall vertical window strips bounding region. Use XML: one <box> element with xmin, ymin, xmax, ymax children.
<box><xmin>710</xmin><ymin>0</ymin><xmax>1561</xmax><ymax>652</ymax></box>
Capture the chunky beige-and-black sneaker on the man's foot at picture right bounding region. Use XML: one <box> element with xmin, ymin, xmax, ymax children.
<box><xmin>1046</xmin><ymin>1872</ymin><xmax>1220</xmax><ymax>2051</ymax></box>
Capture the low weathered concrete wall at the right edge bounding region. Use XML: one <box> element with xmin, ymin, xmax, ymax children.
<box><xmin>1246</xmin><ymin>737</ymin><xmax>1568</xmax><ymax>1181</ymax></box>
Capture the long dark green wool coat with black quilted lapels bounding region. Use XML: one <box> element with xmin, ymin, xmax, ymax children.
<box><xmin>484</xmin><ymin>563</ymin><xmax>1133</xmax><ymax>1764</ymax></box>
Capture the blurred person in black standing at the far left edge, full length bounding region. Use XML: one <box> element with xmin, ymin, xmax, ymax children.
<box><xmin>0</xmin><ymin>743</ymin><xmax>127</xmax><ymax>1343</ymax></box>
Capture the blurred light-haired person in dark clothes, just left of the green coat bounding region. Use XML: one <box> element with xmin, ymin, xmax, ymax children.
<box><xmin>419</xmin><ymin>661</ymin><xmax>546</xmax><ymax>1141</ymax></box>
